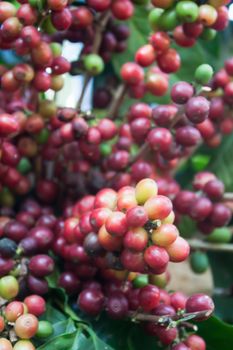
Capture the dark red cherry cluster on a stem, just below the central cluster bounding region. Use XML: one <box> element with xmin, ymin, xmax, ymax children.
<box><xmin>78</xmin><ymin>275</ymin><xmax>214</xmax><ymax>350</ymax></box>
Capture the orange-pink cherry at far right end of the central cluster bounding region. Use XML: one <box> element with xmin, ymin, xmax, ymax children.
<box><xmin>166</xmin><ymin>237</ymin><xmax>190</xmax><ymax>262</ymax></box>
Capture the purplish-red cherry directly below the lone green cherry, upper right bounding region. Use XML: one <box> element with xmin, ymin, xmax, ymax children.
<box><xmin>185</xmin><ymin>96</ymin><xmax>210</xmax><ymax>124</ymax></box>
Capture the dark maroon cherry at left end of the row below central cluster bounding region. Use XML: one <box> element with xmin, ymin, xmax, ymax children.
<box><xmin>77</xmin><ymin>289</ymin><xmax>104</xmax><ymax>316</ymax></box>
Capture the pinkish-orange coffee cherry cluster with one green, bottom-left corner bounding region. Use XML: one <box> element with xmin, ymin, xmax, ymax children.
<box><xmin>0</xmin><ymin>290</ymin><xmax>53</xmax><ymax>350</ymax></box>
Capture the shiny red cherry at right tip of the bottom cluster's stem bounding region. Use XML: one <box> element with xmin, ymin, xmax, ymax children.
<box><xmin>185</xmin><ymin>294</ymin><xmax>214</xmax><ymax>321</ymax></box>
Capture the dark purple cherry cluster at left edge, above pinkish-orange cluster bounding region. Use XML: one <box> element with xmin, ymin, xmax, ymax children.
<box><xmin>0</xmin><ymin>200</ymin><xmax>56</xmax><ymax>297</ymax></box>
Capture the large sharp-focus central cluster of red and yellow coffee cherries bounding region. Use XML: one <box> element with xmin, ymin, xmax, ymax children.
<box><xmin>57</xmin><ymin>179</ymin><xmax>189</xmax><ymax>274</ymax></box>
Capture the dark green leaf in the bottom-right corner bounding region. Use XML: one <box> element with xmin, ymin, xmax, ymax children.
<box><xmin>198</xmin><ymin>317</ymin><xmax>233</xmax><ymax>350</ymax></box>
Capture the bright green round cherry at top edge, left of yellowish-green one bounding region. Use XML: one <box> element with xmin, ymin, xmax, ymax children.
<box><xmin>176</xmin><ymin>1</ymin><xmax>199</xmax><ymax>23</ymax></box>
